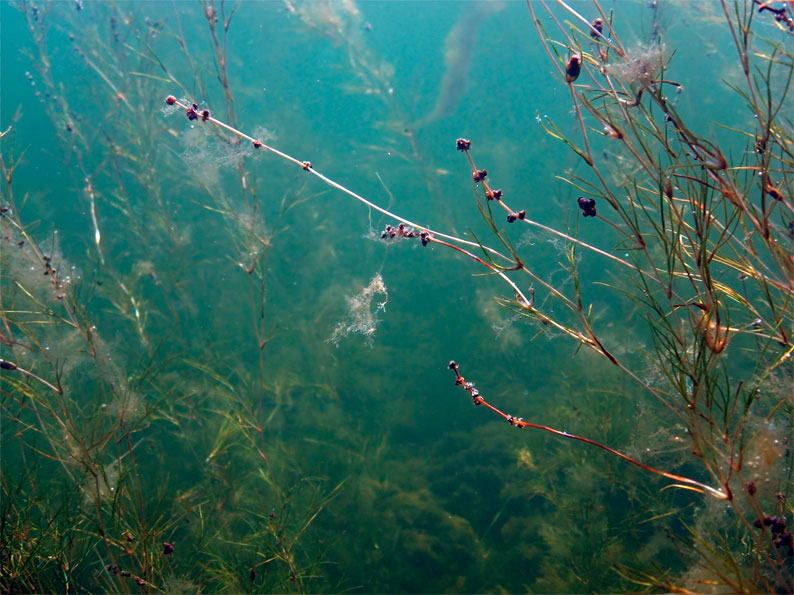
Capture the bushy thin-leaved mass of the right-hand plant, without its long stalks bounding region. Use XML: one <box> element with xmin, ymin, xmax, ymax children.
<box><xmin>529</xmin><ymin>1</ymin><xmax>794</xmax><ymax>591</ymax></box>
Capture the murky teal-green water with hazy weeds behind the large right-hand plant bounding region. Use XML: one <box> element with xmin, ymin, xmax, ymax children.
<box><xmin>0</xmin><ymin>1</ymin><xmax>788</xmax><ymax>592</ymax></box>
